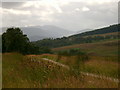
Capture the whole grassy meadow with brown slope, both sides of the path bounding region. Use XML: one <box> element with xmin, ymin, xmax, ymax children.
<box><xmin>2</xmin><ymin>40</ymin><xmax>119</xmax><ymax>88</ymax></box>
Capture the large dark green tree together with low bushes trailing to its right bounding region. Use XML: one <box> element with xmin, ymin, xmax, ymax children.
<box><xmin>2</xmin><ymin>28</ymin><xmax>51</xmax><ymax>54</ymax></box>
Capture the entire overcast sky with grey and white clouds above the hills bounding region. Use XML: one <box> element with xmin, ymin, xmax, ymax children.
<box><xmin>0</xmin><ymin>0</ymin><xmax>119</xmax><ymax>31</ymax></box>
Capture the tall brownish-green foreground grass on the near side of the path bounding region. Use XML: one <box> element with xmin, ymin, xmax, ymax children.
<box><xmin>2</xmin><ymin>53</ymin><xmax>118</xmax><ymax>88</ymax></box>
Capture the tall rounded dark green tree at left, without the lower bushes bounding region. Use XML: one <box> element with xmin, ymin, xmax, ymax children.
<box><xmin>2</xmin><ymin>28</ymin><xmax>29</xmax><ymax>53</ymax></box>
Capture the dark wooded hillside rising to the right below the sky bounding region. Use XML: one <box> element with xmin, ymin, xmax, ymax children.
<box><xmin>33</xmin><ymin>24</ymin><xmax>120</xmax><ymax>48</ymax></box>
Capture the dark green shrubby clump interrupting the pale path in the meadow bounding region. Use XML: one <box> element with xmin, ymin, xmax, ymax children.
<box><xmin>56</xmin><ymin>49</ymin><xmax>88</xmax><ymax>77</ymax></box>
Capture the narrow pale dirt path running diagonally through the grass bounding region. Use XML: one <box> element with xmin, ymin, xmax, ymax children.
<box><xmin>31</xmin><ymin>58</ymin><xmax>119</xmax><ymax>83</ymax></box>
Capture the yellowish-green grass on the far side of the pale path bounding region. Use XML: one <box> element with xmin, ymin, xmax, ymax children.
<box><xmin>37</xmin><ymin>55</ymin><xmax>119</xmax><ymax>78</ymax></box>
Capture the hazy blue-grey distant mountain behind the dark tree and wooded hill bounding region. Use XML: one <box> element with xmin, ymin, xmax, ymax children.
<box><xmin>3</xmin><ymin>25</ymin><xmax>74</xmax><ymax>41</ymax></box>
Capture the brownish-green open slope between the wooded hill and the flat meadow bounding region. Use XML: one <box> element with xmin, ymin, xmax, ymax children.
<box><xmin>52</xmin><ymin>40</ymin><xmax>120</xmax><ymax>57</ymax></box>
